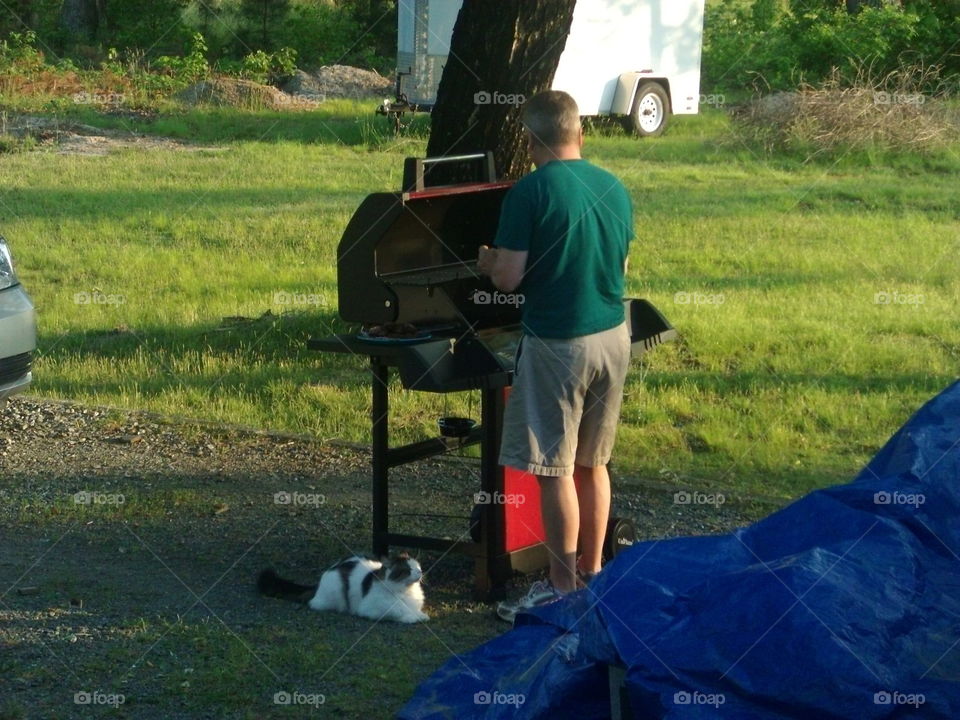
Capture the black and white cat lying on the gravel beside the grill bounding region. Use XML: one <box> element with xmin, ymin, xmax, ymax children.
<box><xmin>257</xmin><ymin>553</ymin><xmax>430</xmax><ymax>623</ymax></box>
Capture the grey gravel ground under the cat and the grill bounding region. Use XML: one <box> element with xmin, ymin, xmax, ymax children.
<box><xmin>0</xmin><ymin>398</ymin><xmax>772</xmax><ymax>718</ymax></box>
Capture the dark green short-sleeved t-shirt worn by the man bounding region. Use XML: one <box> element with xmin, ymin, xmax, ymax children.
<box><xmin>496</xmin><ymin>160</ymin><xmax>633</xmax><ymax>338</ymax></box>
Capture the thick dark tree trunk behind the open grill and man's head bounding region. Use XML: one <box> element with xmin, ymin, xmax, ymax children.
<box><xmin>427</xmin><ymin>0</ymin><xmax>576</xmax><ymax>181</ymax></box>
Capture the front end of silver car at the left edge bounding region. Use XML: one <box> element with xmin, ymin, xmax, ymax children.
<box><xmin>0</xmin><ymin>235</ymin><xmax>37</xmax><ymax>405</ymax></box>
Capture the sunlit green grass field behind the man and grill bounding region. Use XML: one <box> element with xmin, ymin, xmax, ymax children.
<box><xmin>0</xmin><ymin>104</ymin><xmax>960</xmax><ymax>498</ymax></box>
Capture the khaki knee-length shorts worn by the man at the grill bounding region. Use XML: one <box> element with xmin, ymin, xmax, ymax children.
<box><xmin>500</xmin><ymin>323</ymin><xmax>630</xmax><ymax>477</ymax></box>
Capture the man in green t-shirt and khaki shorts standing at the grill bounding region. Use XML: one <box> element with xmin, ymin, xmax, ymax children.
<box><xmin>479</xmin><ymin>90</ymin><xmax>633</xmax><ymax>620</ymax></box>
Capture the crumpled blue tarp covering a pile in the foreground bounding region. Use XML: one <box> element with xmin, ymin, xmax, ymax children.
<box><xmin>399</xmin><ymin>382</ymin><xmax>960</xmax><ymax>720</ymax></box>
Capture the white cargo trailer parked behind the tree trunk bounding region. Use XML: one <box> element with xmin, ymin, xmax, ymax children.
<box><xmin>379</xmin><ymin>0</ymin><xmax>705</xmax><ymax>135</ymax></box>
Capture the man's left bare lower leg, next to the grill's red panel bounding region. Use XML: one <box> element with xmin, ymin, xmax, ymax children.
<box><xmin>537</xmin><ymin>475</ymin><xmax>580</xmax><ymax>593</ymax></box>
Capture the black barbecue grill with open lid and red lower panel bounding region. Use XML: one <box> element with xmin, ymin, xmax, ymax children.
<box><xmin>308</xmin><ymin>153</ymin><xmax>676</xmax><ymax>598</ymax></box>
